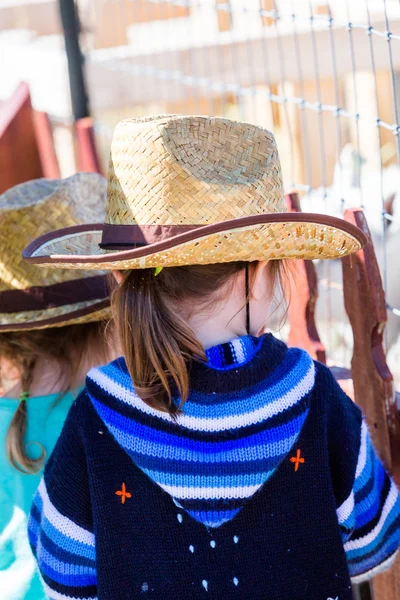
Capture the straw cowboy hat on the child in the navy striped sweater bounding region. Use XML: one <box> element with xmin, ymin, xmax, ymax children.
<box><xmin>24</xmin><ymin>115</ymin><xmax>366</xmax><ymax>269</ymax></box>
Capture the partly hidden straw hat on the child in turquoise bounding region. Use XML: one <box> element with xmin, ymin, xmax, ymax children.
<box><xmin>0</xmin><ymin>173</ymin><xmax>109</xmax><ymax>332</ymax></box>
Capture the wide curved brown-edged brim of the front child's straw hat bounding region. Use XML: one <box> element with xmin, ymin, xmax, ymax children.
<box><xmin>23</xmin><ymin>213</ymin><xmax>368</xmax><ymax>270</ymax></box>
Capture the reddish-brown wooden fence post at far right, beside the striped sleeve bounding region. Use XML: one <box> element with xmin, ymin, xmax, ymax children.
<box><xmin>343</xmin><ymin>209</ymin><xmax>400</xmax><ymax>600</ymax></box>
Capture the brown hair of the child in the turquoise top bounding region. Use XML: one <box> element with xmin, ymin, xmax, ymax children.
<box><xmin>0</xmin><ymin>322</ymin><xmax>107</xmax><ymax>473</ymax></box>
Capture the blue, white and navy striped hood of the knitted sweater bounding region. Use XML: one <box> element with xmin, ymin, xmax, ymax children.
<box><xmin>86</xmin><ymin>334</ymin><xmax>315</xmax><ymax>527</ymax></box>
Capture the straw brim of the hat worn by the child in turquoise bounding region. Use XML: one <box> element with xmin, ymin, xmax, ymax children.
<box><xmin>0</xmin><ymin>298</ymin><xmax>111</xmax><ymax>333</ymax></box>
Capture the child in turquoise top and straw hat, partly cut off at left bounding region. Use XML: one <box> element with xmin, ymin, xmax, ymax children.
<box><xmin>0</xmin><ymin>174</ymin><xmax>115</xmax><ymax>600</ymax></box>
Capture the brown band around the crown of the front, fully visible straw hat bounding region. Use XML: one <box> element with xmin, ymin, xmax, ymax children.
<box><xmin>99</xmin><ymin>223</ymin><xmax>201</xmax><ymax>250</ymax></box>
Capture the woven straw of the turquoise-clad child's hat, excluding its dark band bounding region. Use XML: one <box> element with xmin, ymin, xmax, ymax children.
<box><xmin>0</xmin><ymin>173</ymin><xmax>108</xmax><ymax>330</ymax></box>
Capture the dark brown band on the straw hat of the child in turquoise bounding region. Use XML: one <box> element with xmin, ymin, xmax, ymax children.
<box><xmin>0</xmin><ymin>275</ymin><xmax>109</xmax><ymax>313</ymax></box>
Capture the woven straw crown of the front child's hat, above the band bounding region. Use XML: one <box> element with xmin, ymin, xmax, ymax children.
<box><xmin>106</xmin><ymin>115</ymin><xmax>286</xmax><ymax>225</ymax></box>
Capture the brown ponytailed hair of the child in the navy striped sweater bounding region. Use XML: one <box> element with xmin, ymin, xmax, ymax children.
<box><xmin>112</xmin><ymin>261</ymin><xmax>282</xmax><ymax>415</ymax></box>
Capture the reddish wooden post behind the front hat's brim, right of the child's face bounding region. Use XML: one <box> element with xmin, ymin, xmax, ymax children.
<box><xmin>285</xmin><ymin>192</ymin><xmax>326</xmax><ymax>364</ymax></box>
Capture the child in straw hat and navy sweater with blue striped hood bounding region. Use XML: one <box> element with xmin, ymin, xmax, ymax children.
<box><xmin>24</xmin><ymin>116</ymin><xmax>400</xmax><ymax>600</ymax></box>
